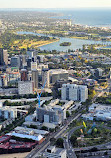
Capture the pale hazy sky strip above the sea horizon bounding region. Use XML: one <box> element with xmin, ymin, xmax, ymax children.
<box><xmin>0</xmin><ymin>0</ymin><xmax>111</xmax><ymax>8</ymax></box>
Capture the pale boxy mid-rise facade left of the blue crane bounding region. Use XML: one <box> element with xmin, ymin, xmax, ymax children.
<box><xmin>18</xmin><ymin>81</ymin><xmax>33</xmax><ymax>94</ymax></box>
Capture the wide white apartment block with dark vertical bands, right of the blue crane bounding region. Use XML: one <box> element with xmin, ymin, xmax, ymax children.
<box><xmin>61</xmin><ymin>84</ymin><xmax>88</xmax><ymax>102</ymax></box>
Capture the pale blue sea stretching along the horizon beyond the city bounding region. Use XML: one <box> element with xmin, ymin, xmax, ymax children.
<box><xmin>0</xmin><ymin>8</ymin><xmax>111</xmax><ymax>28</ymax></box>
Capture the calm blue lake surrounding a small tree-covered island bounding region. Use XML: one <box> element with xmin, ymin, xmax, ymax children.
<box><xmin>18</xmin><ymin>32</ymin><xmax>111</xmax><ymax>52</ymax></box>
